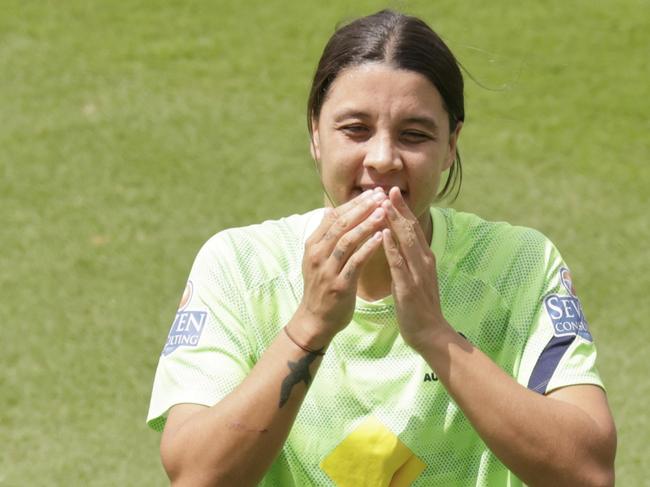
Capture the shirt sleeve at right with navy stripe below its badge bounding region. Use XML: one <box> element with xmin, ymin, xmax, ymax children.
<box><xmin>517</xmin><ymin>240</ymin><xmax>604</xmax><ymax>394</ymax></box>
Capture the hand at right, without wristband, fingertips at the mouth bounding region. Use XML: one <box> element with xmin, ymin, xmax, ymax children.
<box><xmin>382</xmin><ymin>188</ymin><xmax>450</xmax><ymax>351</ymax></box>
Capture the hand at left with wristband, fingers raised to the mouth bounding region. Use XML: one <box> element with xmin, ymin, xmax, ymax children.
<box><xmin>292</xmin><ymin>190</ymin><xmax>386</xmax><ymax>349</ymax></box>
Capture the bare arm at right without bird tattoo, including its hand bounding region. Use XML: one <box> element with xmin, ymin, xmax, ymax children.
<box><xmin>374</xmin><ymin>188</ymin><xmax>616</xmax><ymax>485</ymax></box>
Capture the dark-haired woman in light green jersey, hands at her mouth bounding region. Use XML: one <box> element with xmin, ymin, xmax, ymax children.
<box><xmin>148</xmin><ymin>11</ymin><xmax>616</xmax><ymax>487</ymax></box>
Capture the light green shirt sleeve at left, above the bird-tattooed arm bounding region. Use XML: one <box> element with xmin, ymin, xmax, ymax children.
<box><xmin>147</xmin><ymin>234</ymin><xmax>254</xmax><ymax>431</ymax></box>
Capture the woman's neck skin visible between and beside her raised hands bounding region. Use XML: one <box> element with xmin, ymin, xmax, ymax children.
<box><xmin>357</xmin><ymin>211</ymin><xmax>433</xmax><ymax>301</ymax></box>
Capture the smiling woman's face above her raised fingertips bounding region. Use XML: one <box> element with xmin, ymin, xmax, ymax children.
<box><xmin>312</xmin><ymin>63</ymin><xmax>461</xmax><ymax>226</ymax></box>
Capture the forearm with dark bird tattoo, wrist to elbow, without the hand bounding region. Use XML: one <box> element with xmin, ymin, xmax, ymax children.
<box><xmin>161</xmin><ymin>318</ymin><xmax>321</xmax><ymax>486</ymax></box>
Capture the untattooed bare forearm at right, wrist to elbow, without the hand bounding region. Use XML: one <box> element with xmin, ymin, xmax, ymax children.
<box><xmin>418</xmin><ymin>327</ymin><xmax>613</xmax><ymax>486</ymax></box>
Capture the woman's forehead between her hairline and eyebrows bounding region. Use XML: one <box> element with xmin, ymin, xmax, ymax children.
<box><xmin>321</xmin><ymin>63</ymin><xmax>447</xmax><ymax>123</ymax></box>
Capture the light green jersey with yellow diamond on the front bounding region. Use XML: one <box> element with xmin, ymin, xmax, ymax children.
<box><xmin>147</xmin><ymin>208</ymin><xmax>602</xmax><ymax>487</ymax></box>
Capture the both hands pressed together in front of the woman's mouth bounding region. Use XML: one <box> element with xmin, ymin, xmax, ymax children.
<box><xmin>291</xmin><ymin>186</ymin><xmax>449</xmax><ymax>351</ymax></box>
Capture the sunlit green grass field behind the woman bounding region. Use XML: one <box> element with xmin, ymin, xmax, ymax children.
<box><xmin>0</xmin><ymin>0</ymin><xmax>650</xmax><ymax>486</ymax></box>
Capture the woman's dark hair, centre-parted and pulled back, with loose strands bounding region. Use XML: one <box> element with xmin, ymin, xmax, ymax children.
<box><xmin>307</xmin><ymin>10</ymin><xmax>465</xmax><ymax>199</ymax></box>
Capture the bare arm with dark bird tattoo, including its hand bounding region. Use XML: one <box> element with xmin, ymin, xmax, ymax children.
<box><xmin>161</xmin><ymin>191</ymin><xmax>386</xmax><ymax>486</ymax></box>
